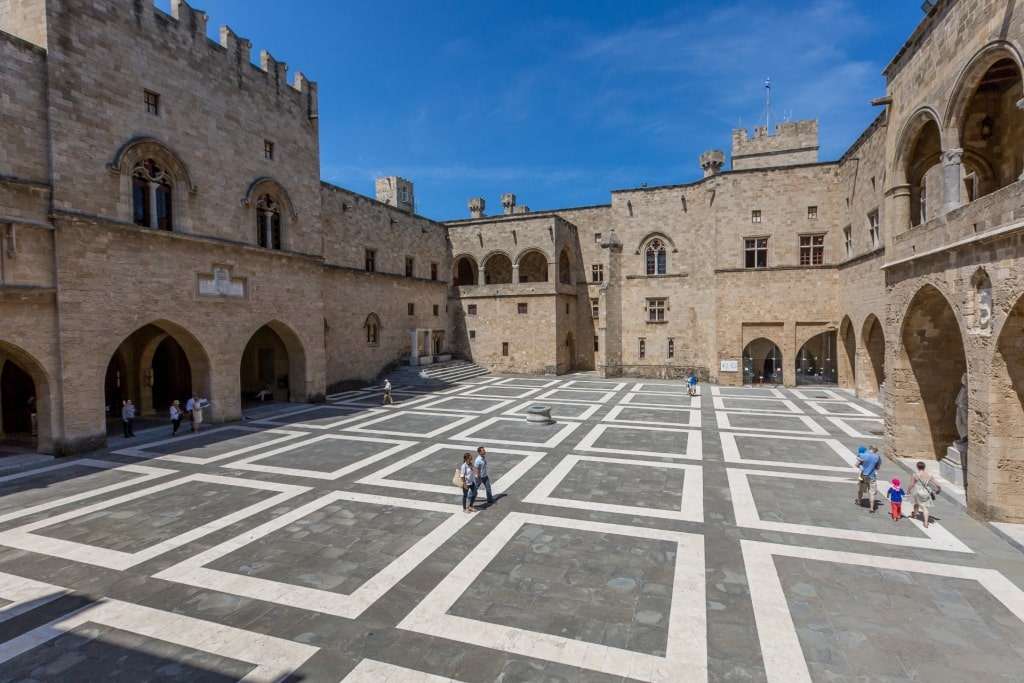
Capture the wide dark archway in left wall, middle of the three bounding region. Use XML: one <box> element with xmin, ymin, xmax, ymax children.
<box><xmin>103</xmin><ymin>321</ymin><xmax>210</xmax><ymax>421</ymax></box>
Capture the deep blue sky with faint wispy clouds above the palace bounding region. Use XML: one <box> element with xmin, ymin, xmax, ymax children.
<box><xmin>176</xmin><ymin>0</ymin><xmax>924</xmax><ymax>220</ymax></box>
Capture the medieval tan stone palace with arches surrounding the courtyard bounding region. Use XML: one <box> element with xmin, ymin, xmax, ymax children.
<box><xmin>0</xmin><ymin>0</ymin><xmax>1024</xmax><ymax>521</ymax></box>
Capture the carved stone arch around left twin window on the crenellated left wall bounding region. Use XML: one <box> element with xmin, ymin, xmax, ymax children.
<box><xmin>106</xmin><ymin>137</ymin><xmax>198</xmax><ymax>232</ymax></box>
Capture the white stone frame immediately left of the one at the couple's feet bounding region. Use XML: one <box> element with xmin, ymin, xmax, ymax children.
<box><xmin>0</xmin><ymin>474</ymin><xmax>309</xmax><ymax>569</ymax></box>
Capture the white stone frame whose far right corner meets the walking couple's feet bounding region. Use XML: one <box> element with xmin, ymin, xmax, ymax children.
<box><xmin>155</xmin><ymin>486</ymin><xmax>472</xmax><ymax>618</ymax></box>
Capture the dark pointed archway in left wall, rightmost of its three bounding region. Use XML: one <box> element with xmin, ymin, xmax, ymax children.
<box><xmin>239</xmin><ymin>321</ymin><xmax>306</xmax><ymax>403</ymax></box>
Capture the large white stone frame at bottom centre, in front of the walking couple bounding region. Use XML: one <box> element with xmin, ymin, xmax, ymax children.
<box><xmin>398</xmin><ymin>512</ymin><xmax>708</xmax><ymax>683</ymax></box>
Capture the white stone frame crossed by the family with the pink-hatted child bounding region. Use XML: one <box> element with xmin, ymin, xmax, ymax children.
<box><xmin>726</xmin><ymin>469</ymin><xmax>974</xmax><ymax>554</ymax></box>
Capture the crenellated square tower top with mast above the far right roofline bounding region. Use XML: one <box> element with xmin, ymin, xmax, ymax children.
<box><xmin>732</xmin><ymin>119</ymin><xmax>818</xmax><ymax>171</ymax></box>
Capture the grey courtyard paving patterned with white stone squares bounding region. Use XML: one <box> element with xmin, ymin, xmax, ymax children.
<box><xmin>0</xmin><ymin>375</ymin><xmax>1024</xmax><ymax>683</ymax></box>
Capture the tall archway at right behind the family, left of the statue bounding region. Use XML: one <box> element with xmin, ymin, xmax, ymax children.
<box><xmin>886</xmin><ymin>285</ymin><xmax>967</xmax><ymax>459</ymax></box>
